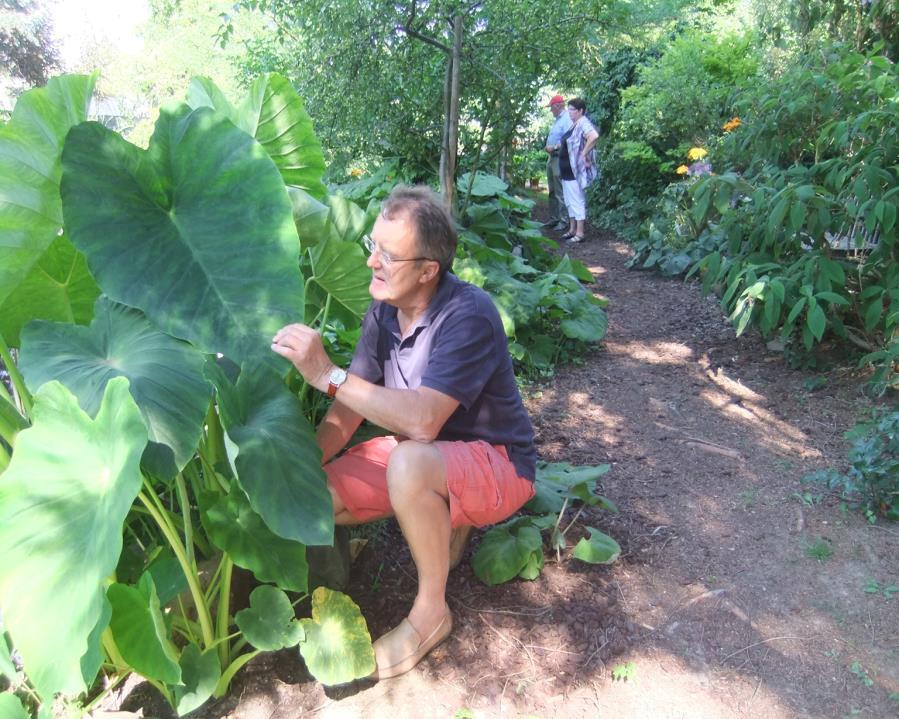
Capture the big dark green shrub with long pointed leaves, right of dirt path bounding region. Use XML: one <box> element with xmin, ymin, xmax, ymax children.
<box><xmin>633</xmin><ymin>41</ymin><xmax>899</xmax><ymax>391</ymax></box>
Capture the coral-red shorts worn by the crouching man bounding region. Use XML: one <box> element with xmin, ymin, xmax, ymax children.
<box><xmin>325</xmin><ymin>436</ymin><xmax>534</xmax><ymax>527</ymax></box>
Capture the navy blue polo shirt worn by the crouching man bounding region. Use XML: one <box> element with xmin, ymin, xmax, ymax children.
<box><xmin>349</xmin><ymin>273</ymin><xmax>537</xmax><ymax>482</ymax></box>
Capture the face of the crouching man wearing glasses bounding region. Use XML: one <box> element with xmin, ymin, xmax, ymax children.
<box><xmin>366</xmin><ymin>215</ymin><xmax>435</xmax><ymax>307</ymax></box>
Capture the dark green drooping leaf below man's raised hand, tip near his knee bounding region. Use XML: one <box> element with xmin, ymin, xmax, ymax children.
<box><xmin>207</xmin><ymin>363</ymin><xmax>334</xmax><ymax>544</ymax></box>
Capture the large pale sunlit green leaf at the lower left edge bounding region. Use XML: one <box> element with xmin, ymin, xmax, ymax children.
<box><xmin>0</xmin><ymin>377</ymin><xmax>147</xmax><ymax>698</ymax></box>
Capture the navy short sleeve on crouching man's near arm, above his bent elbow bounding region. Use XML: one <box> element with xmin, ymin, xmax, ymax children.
<box><xmin>421</xmin><ymin>307</ymin><xmax>505</xmax><ymax>410</ymax></box>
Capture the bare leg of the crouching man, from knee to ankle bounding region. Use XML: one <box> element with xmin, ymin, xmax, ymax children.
<box><xmin>387</xmin><ymin>440</ymin><xmax>450</xmax><ymax>637</ymax></box>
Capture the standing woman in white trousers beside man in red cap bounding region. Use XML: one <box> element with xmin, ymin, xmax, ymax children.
<box><xmin>559</xmin><ymin>97</ymin><xmax>599</xmax><ymax>242</ymax></box>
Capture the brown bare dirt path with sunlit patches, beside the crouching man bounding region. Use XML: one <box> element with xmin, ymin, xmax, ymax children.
<box><xmin>112</xmin><ymin>222</ymin><xmax>899</xmax><ymax>719</ymax></box>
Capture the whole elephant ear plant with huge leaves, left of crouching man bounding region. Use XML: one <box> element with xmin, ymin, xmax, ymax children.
<box><xmin>0</xmin><ymin>76</ymin><xmax>374</xmax><ymax>716</ymax></box>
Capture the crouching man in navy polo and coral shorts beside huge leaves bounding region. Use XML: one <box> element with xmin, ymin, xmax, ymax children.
<box><xmin>272</xmin><ymin>187</ymin><xmax>536</xmax><ymax>679</ymax></box>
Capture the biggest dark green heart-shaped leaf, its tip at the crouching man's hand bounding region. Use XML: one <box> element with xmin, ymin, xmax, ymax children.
<box><xmin>62</xmin><ymin>105</ymin><xmax>303</xmax><ymax>362</ymax></box>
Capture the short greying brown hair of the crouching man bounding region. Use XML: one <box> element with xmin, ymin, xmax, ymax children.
<box><xmin>381</xmin><ymin>185</ymin><xmax>458</xmax><ymax>277</ymax></box>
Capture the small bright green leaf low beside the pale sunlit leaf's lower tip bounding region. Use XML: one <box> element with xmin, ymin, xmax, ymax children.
<box><xmin>106</xmin><ymin>574</ymin><xmax>181</xmax><ymax>684</ymax></box>
